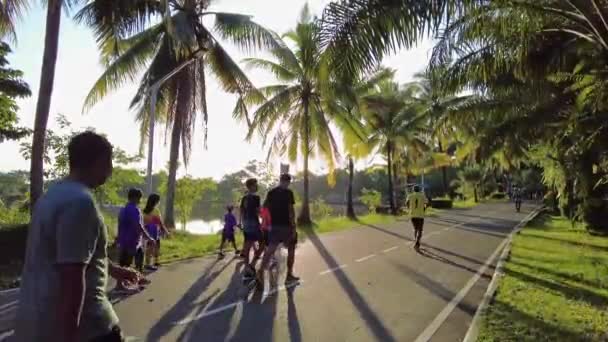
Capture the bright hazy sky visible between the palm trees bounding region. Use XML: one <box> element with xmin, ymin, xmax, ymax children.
<box><xmin>0</xmin><ymin>0</ymin><xmax>432</xmax><ymax>179</ymax></box>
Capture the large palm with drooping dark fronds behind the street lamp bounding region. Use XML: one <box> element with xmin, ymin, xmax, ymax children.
<box><xmin>78</xmin><ymin>0</ymin><xmax>276</xmax><ymax>226</ymax></box>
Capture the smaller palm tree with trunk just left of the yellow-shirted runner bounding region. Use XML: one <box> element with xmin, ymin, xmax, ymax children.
<box><xmin>364</xmin><ymin>81</ymin><xmax>428</xmax><ymax>214</ymax></box>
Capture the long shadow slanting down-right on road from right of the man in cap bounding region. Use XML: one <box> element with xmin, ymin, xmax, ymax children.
<box><xmin>308</xmin><ymin>227</ymin><xmax>397</xmax><ymax>342</ymax></box>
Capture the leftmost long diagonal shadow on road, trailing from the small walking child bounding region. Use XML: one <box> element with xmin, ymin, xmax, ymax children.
<box><xmin>146</xmin><ymin>259</ymin><xmax>235</xmax><ymax>341</ymax></box>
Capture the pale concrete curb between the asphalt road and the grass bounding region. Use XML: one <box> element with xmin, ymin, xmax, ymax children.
<box><xmin>462</xmin><ymin>206</ymin><xmax>544</xmax><ymax>342</ymax></box>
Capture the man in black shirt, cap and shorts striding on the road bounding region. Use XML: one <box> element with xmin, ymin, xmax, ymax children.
<box><xmin>257</xmin><ymin>174</ymin><xmax>300</xmax><ymax>288</ymax></box>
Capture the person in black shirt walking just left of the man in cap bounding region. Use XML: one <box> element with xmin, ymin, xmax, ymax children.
<box><xmin>240</xmin><ymin>178</ymin><xmax>262</xmax><ymax>275</ymax></box>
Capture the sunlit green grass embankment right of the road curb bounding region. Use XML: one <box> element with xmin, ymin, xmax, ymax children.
<box><xmin>478</xmin><ymin>215</ymin><xmax>608</xmax><ymax>342</ymax></box>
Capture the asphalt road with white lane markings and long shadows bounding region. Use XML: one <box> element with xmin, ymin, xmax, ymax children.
<box><xmin>0</xmin><ymin>204</ymin><xmax>533</xmax><ymax>342</ymax></box>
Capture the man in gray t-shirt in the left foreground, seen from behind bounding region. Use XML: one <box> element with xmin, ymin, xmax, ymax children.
<box><xmin>15</xmin><ymin>132</ymin><xmax>138</xmax><ymax>342</ymax></box>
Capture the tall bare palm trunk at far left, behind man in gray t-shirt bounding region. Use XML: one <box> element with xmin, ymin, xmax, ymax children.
<box><xmin>30</xmin><ymin>0</ymin><xmax>63</xmax><ymax>213</ymax></box>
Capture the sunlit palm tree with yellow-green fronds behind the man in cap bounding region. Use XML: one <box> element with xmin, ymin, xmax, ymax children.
<box><xmin>235</xmin><ymin>6</ymin><xmax>350</xmax><ymax>225</ymax></box>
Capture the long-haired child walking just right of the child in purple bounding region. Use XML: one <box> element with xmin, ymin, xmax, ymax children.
<box><xmin>144</xmin><ymin>194</ymin><xmax>169</xmax><ymax>271</ymax></box>
